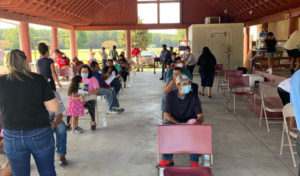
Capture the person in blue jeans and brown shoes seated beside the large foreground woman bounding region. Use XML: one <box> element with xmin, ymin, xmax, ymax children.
<box><xmin>49</xmin><ymin>91</ymin><xmax>68</xmax><ymax>166</ymax></box>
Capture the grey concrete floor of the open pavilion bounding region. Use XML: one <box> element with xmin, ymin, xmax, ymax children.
<box><xmin>31</xmin><ymin>71</ymin><xmax>299</xmax><ymax>176</ymax></box>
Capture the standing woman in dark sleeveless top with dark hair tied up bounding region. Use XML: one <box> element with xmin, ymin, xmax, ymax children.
<box><xmin>36</xmin><ymin>43</ymin><xmax>61</xmax><ymax>91</ymax></box>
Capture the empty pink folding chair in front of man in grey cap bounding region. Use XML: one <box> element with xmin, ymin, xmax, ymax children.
<box><xmin>157</xmin><ymin>125</ymin><xmax>213</xmax><ymax>176</ymax></box>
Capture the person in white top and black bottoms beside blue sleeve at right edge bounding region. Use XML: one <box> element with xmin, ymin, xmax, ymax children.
<box><xmin>277</xmin><ymin>78</ymin><xmax>297</xmax><ymax>128</ymax></box>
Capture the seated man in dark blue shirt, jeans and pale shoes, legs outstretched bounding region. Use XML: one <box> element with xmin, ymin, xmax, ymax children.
<box><xmin>90</xmin><ymin>61</ymin><xmax>124</xmax><ymax>114</ymax></box>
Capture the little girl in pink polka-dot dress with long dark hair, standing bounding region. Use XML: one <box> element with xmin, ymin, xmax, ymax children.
<box><xmin>67</xmin><ymin>75</ymin><xmax>84</xmax><ymax>134</ymax></box>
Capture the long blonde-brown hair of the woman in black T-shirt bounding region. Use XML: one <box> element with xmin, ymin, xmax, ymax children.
<box><xmin>6</xmin><ymin>49</ymin><xmax>32</xmax><ymax>81</ymax></box>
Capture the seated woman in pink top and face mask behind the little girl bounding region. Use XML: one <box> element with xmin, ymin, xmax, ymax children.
<box><xmin>78</xmin><ymin>65</ymin><xmax>100</xmax><ymax>130</ymax></box>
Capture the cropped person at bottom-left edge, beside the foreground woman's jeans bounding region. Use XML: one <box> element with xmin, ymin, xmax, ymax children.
<box><xmin>0</xmin><ymin>112</ymin><xmax>12</xmax><ymax>176</ymax></box>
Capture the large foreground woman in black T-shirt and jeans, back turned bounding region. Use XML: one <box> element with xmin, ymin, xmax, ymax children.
<box><xmin>0</xmin><ymin>47</ymin><xmax>59</xmax><ymax>176</ymax></box>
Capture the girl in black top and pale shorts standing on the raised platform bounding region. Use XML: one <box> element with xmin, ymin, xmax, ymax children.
<box><xmin>265</xmin><ymin>32</ymin><xmax>277</xmax><ymax>74</ymax></box>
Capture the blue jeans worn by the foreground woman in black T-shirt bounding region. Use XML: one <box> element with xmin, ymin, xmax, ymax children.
<box><xmin>4</xmin><ymin>126</ymin><xmax>56</xmax><ymax>176</ymax></box>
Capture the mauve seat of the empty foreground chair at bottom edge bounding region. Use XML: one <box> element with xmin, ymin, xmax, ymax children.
<box><xmin>164</xmin><ymin>167</ymin><xmax>214</xmax><ymax>176</ymax></box>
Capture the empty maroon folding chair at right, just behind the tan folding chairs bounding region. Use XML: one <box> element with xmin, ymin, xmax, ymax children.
<box><xmin>226</xmin><ymin>76</ymin><xmax>254</xmax><ymax>114</ymax></box>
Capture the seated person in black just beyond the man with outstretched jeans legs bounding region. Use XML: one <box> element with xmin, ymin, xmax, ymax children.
<box><xmin>101</xmin><ymin>59</ymin><xmax>122</xmax><ymax>94</ymax></box>
